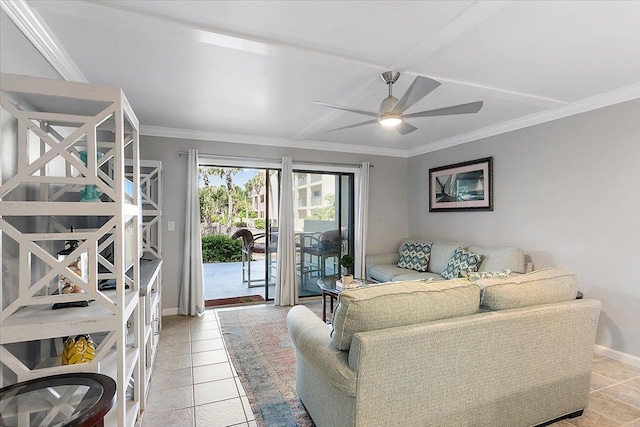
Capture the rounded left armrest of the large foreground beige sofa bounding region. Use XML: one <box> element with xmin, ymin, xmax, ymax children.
<box><xmin>287</xmin><ymin>305</ymin><xmax>356</xmax><ymax>396</ymax></box>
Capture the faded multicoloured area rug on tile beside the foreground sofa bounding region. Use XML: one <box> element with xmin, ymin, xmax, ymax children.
<box><xmin>218</xmin><ymin>302</ymin><xmax>322</xmax><ymax>427</ymax></box>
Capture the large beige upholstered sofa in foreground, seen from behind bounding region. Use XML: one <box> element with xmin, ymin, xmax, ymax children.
<box><xmin>287</xmin><ymin>268</ymin><xmax>600</xmax><ymax>427</ymax></box>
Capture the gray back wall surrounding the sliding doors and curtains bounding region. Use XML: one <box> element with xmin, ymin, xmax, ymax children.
<box><xmin>140</xmin><ymin>136</ymin><xmax>408</xmax><ymax>309</ymax></box>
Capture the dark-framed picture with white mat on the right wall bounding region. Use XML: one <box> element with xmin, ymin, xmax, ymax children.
<box><xmin>429</xmin><ymin>157</ymin><xmax>493</xmax><ymax>212</ymax></box>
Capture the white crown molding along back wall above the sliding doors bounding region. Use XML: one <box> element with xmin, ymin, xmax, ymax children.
<box><xmin>140</xmin><ymin>126</ymin><xmax>407</xmax><ymax>158</ymax></box>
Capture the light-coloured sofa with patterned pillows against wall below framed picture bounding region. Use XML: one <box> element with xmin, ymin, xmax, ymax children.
<box><xmin>365</xmin><ymin>239</ymin><xmax>533</xmax><ymax>283</ymax></box>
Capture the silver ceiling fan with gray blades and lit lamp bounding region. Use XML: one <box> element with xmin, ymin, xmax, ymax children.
<box><xmin>313</xmin><ymin>71</ymin><xmax>482</xmax><ymax>135</ymax></box>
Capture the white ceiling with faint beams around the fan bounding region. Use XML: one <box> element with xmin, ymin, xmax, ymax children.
<box><xmin>3</xmin><ymin>0</ymin><xmax>640</xmax><ymax>156</ymax></box>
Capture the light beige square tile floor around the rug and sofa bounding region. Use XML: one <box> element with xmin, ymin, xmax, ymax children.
<box><xmin>142</xmin><ymin>305</ymin><xmax>640</xmax><ymax>427</ymax></box>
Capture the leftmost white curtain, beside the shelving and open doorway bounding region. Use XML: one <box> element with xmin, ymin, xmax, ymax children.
<box><xmin>178</xmin><ymin>148</ymin><xmax>204</xmax><ymax>316</ymax></box>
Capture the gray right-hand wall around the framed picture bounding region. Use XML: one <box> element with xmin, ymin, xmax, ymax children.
<box><xmin>408</xmin><ymin>100</ymin><xmax>640</xmax><ymax>357</ymax></box>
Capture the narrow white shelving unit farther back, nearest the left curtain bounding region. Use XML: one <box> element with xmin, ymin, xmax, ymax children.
<box><xmin>125</xmin><ymin>160</ymin><xmax>162</xmax><ymax>411</ymax></box>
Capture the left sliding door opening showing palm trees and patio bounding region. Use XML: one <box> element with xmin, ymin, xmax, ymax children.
<box><xmin>200</xmin><ymin>165</ymin><xmax>280</xmax><ymax>306</ymax></box>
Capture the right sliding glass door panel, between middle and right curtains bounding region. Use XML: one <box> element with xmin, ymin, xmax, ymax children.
<box><xmin>293</xmin><ymin>170</ymin><xmax>354</xmax><ymax>297</ymax></box>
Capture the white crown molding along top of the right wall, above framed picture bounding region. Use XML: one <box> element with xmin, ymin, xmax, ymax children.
<box><xmin>408</xmin><ymin>83</ymin><xmax>640</xmax><ymax>157</ymax></box>
